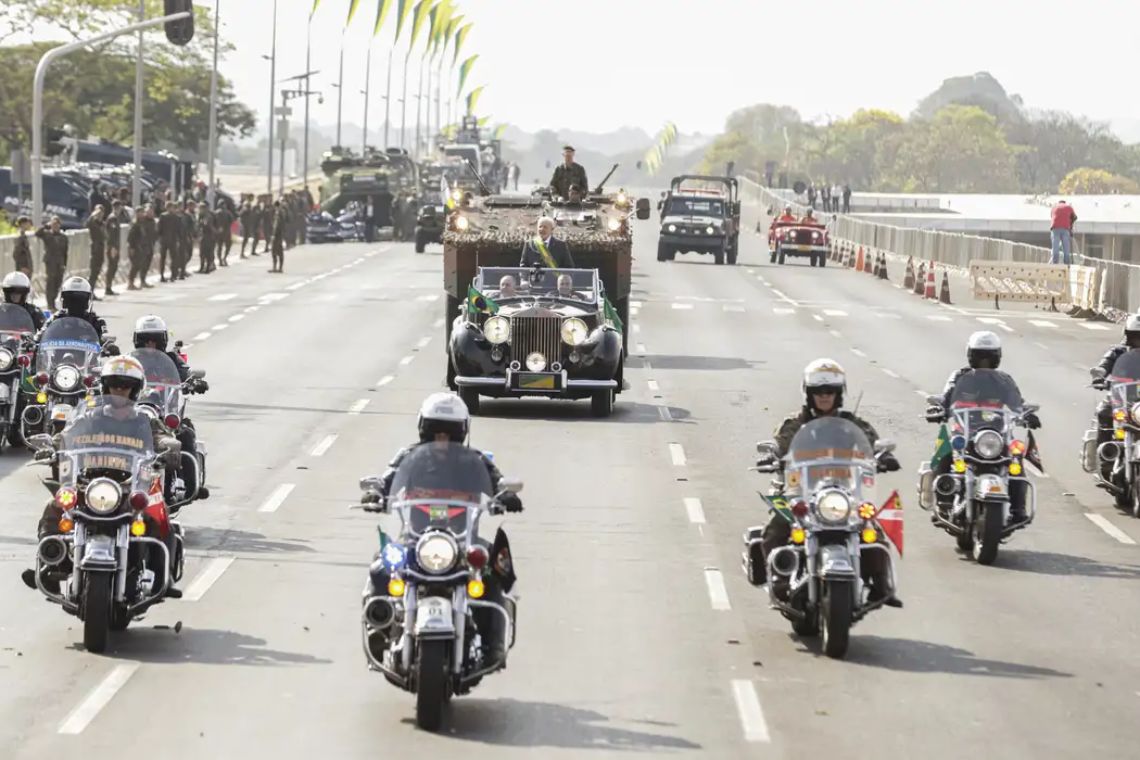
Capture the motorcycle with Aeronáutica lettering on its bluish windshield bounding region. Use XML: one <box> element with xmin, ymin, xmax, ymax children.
<box><xmin>21</xmin><ymin>317</ymin><xmax>117</xmax><ymax>441</ymax></box>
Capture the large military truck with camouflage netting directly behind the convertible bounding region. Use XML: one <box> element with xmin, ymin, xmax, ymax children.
<box><xmin>443</xmin><ymin>172</ymin><xmax>650</xmax><ymax>380</ymax></box>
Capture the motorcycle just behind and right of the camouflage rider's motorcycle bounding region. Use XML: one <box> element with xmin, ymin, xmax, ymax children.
<box><xmin>918</xmin><ymin>369</ymin><xmax>1042</xmax><ymax>565</ymax></box>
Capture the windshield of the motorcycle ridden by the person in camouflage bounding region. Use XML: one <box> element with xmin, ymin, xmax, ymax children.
<box><xmin>785</xmin><ymin>417</ymin><xmax>876</xmax><ymax>500</ymax></box>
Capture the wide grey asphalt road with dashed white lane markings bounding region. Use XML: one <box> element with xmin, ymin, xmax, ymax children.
<box><xmin>0</xmin><ymin>209</ymin><xmax>1140</xmax><ymax>759</ymax></box>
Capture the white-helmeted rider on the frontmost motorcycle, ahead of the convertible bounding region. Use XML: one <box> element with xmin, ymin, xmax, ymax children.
<box><xmin>361</xmin><ymin>393</ymin><xmax>522</xmax><ymax>662</ymax></box>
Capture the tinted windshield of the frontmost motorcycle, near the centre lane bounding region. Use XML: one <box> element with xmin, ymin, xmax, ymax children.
<box><xmin>389</xmin><ymin>442</ymin><xmax>495</xmax><ymax>534</ymax></box>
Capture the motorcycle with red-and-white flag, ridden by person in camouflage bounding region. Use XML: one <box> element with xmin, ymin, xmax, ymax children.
<box><xmin>744</xmin><ymin>417</ymin><xmax>896</xmax><ymax>659</ymax></box>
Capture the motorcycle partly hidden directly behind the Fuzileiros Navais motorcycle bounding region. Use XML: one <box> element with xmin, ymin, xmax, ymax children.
<box><xmin>131</xmin><ymin>343</ymin><xmax>206</xmax><ymax>514</ymax></box>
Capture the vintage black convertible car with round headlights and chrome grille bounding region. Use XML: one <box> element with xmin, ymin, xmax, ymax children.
<box><xmin>448</xmin><ymin>267</ymin><xmax>622</xmax><ymax>417</ymax></box>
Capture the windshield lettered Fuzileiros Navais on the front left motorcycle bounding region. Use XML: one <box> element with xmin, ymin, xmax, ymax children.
<box><xmin>59</xmin><ymin>395</ymin><xmax>155</xmax><ymax>484</ymax></box>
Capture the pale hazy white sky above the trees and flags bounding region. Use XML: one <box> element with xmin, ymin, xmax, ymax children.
<box><xmin>120</xmin><ymin>0</ymin><xmax>1140</xmax><ymax>138</ymax></box>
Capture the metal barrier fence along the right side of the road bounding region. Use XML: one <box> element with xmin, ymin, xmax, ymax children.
<box><xmin>740</xmin><ymin>177</ymin><xmax>1140</xmax><ymax>317</ymax></box>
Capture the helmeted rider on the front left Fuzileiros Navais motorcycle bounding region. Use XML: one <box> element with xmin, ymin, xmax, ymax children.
<box><xmin>21</xmin><ymin>357</ymin><xmax>182</xmax><ymax>598</ymax></box>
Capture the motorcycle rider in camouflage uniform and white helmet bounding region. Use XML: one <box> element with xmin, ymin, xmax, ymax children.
<box><xmin>754</xmin><ymin>359</ymin><xmax>903</xmax><ymax>607</ymax></box>
